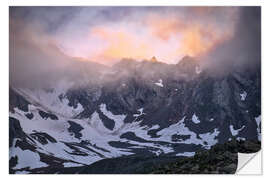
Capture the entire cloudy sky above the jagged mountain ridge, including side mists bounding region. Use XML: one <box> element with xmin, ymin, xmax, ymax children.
<box><xmin>9</xmin><ymin>6</ymin><xmax>261</xmax><ymax>88</ymax></box>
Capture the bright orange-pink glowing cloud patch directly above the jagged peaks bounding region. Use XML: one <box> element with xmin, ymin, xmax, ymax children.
<box><xmin>62</xmin><ymin>14</ymin><xmax>233</xmax><ymax>64</ymax></box>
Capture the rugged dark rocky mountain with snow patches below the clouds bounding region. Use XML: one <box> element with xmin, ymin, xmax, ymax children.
<box><xmin>9</xmin><ymin>57</ymin><xmax>261</xmax><ymax>173</ymax></box>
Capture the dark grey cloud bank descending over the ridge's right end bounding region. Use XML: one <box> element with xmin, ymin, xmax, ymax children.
<box><xmin>201</xmin><ymin>7</ymin><xmax>261</xmax><ymax>74</ymax></box>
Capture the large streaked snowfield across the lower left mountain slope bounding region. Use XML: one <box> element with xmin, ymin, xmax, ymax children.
<box><xmin>9</xmin><ymin>93</ymin><xmax>223</xmax><ymax>173</ymax></box>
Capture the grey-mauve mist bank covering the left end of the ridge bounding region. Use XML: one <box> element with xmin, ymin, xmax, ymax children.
<box><xmin>9</xmin><ymin>16</ymin><xmax>105</xmax><ymax>88</ymax></box>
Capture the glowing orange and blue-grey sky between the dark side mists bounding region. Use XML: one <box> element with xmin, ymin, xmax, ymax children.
<box><xmin>10</xmin><ymin>7</ymin><xmax>238</xmax><ymax>64</ymax></box>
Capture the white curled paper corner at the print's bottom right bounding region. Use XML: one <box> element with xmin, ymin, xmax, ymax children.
<box><xmin>236</xmin><ymin>151</ymin><xmax>262</xmax><ymax>175</ymax></box>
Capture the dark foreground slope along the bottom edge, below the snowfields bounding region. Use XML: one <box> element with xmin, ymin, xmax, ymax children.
<box><xmin>22</xmin><ymin>140</ymin><xmax>261</xmax><ymax>174</ymax></box>
